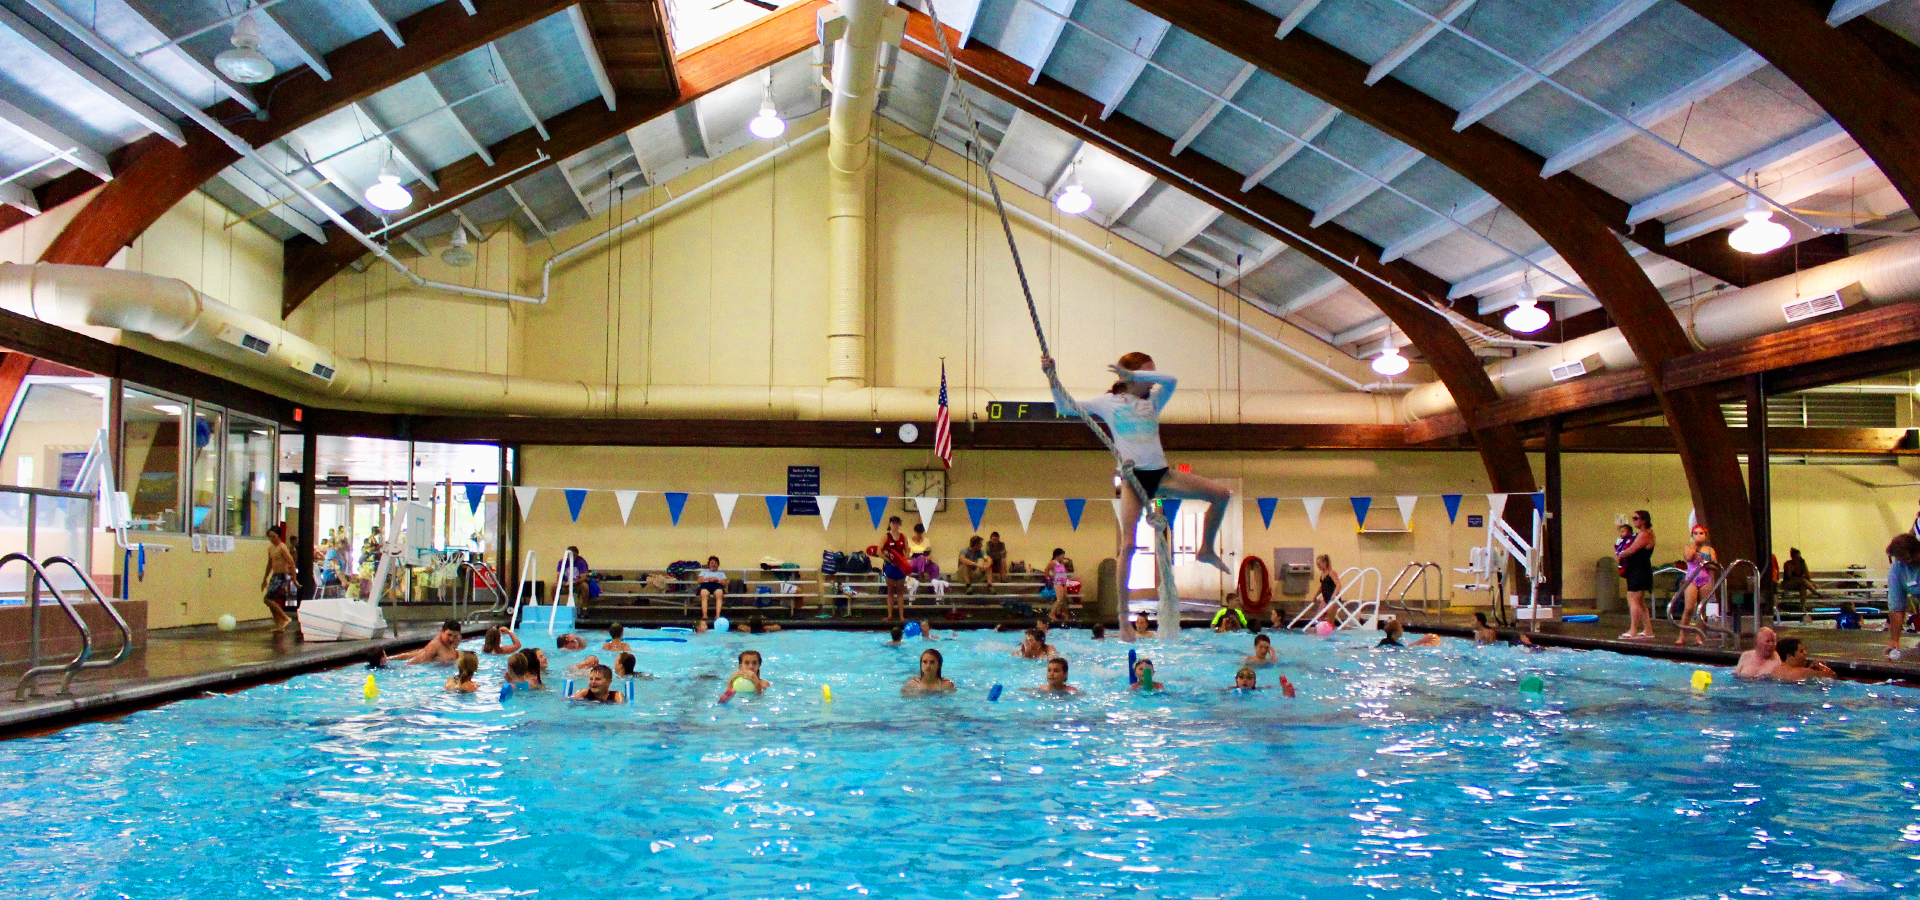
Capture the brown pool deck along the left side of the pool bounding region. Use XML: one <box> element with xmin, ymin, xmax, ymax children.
<box><xmin>0</xmin><ymin>622</ymin><xmax>462</xmax><ymax>739</ymax></box>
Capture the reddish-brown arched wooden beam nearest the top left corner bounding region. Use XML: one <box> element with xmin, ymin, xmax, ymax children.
<box><xmin>40</xmin><ymin>0</ymin><xmax>572</xmax><ymax>265</ymax></box>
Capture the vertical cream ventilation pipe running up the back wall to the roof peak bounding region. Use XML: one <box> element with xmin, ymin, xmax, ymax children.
<box><xmin>820</xmin><ymin>0</ymin><xmax>906</xmax><ymax>391</ymax></box>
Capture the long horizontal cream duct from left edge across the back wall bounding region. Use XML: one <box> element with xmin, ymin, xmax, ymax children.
<box><xmin>0</xmin><ymin>263</ymin><xmax>1402</xmax><ymax>424</ymax></box>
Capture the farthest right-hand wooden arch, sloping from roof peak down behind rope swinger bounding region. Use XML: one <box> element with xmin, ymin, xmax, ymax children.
<box><xmin>900</xmin><ymin>12</ymin><xmax>1534</xmax><ymax>512</ymax></box>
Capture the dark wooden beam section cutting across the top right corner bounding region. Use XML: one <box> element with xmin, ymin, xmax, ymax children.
<box><xmin>1680</xmin><ymin>0</ymin><xmax>1920</xmax><ymax>209</ymax></box>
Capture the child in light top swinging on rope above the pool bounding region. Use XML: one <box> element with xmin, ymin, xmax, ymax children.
<box><xmin>1041</xmin><ymin>351</ymin><xmax>1233</xmax><ymax>606</ymax></box>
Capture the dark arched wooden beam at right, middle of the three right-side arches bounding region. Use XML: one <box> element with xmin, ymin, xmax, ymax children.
<box><xmin>1131</xmin><ymin>0</ymin><xmax>1772</xmax><ymax>557</ymax></box>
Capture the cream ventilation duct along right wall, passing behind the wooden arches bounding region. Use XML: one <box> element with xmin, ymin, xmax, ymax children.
<box><xmin>1405</xmin><ymin>240</ymin><xmax>1920</xmax><ymax>420</ymax></box>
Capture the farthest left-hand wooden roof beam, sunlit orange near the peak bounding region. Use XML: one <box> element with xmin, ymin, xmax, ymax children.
<box><xmin>280</xmin><ymin>0</ymin><xmax>828</xmax><ymax>313</ymax></box>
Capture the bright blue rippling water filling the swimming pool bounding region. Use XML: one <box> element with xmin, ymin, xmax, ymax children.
<box><xmin>0</xmin><ymin>631</ymin><xmax>1920</xmax><ymax>900</ymax></box>
